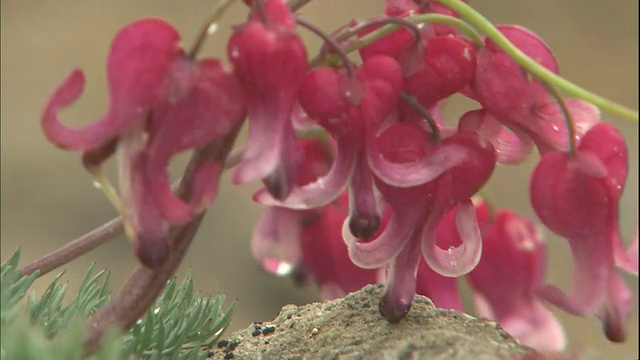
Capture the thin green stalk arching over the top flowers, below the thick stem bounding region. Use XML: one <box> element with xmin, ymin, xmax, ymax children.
<box><xmin>345</xmin><ymin>14</ymin><xmax>482</xmax><ymax>53</ymax></box>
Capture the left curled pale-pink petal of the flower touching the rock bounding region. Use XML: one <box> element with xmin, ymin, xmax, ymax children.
<box><xmin>342</xmin><ymin>209</ymin><xmax>421</xmax><ymax>269</ymax></box>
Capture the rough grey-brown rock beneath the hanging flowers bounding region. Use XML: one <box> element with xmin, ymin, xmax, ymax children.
<box><xmin>212</xmin><ymin>285</ymin><xmax>544</xmax><ymax>360</ymax></box>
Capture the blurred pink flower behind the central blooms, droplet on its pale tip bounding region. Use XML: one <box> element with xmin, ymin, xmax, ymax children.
<box><xmin>251</xmin><ymin>140</ymin><xmax>377</xmax><ymax>299</ymax></box>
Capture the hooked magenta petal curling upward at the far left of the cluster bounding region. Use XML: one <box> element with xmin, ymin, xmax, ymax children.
<box><xmin>41</xmin><ymin>69</ymin><xmax>120</xmax><ymax>150</ymax></box>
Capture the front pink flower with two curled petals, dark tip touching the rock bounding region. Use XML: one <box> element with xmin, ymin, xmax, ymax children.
<box><xmin>343</xmin><ymin>122</ymin><xmax>495</xmax><ymax>321</ymax></box>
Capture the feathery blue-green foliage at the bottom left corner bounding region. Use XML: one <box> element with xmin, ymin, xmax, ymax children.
<box><xmin>1</xmin><ymin>250</ymin><xmax>235</xmax><ymax>360</ymax></box>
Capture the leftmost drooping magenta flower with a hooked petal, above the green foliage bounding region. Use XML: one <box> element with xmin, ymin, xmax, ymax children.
<box><xmin>42</xmin><ymin>19</ymin><xmax>244</xmax><ymax>266</ymax></box>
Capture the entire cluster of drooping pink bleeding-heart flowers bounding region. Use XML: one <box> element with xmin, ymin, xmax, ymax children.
<box><xmin>42</xmin><ymin>0</ymin><xmax>638</xmax><ymax>352</ymax></box>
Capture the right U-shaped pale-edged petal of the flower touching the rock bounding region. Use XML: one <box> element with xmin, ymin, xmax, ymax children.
<box><xmin>422</xmin><ymin>200</ymin><xmax>482</xmax><ymax>277</ymax></box>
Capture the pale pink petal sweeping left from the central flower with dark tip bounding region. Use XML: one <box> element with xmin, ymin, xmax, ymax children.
<box><xmin>253</xmin><ymin>141</ymin><xmax>358</xmax><ymax>209</ymax></box>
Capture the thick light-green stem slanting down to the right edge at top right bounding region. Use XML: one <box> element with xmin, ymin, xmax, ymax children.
<box><xmin>438</xmin><ymin>0</ymin><xmax>638</xmax><ymax>122</ymax></box>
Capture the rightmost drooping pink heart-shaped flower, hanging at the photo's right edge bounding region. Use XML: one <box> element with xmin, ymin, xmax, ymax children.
<box><xmin>530</xmin><ymin>123</ymin><xmax>638</xmax><ymax>341</ymax></box>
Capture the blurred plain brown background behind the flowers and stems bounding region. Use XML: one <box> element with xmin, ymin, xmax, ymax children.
<box><xmin>1</xmin><ymin>0</ymin><xmax>638</xmax><ymax>359</ymax></box>
